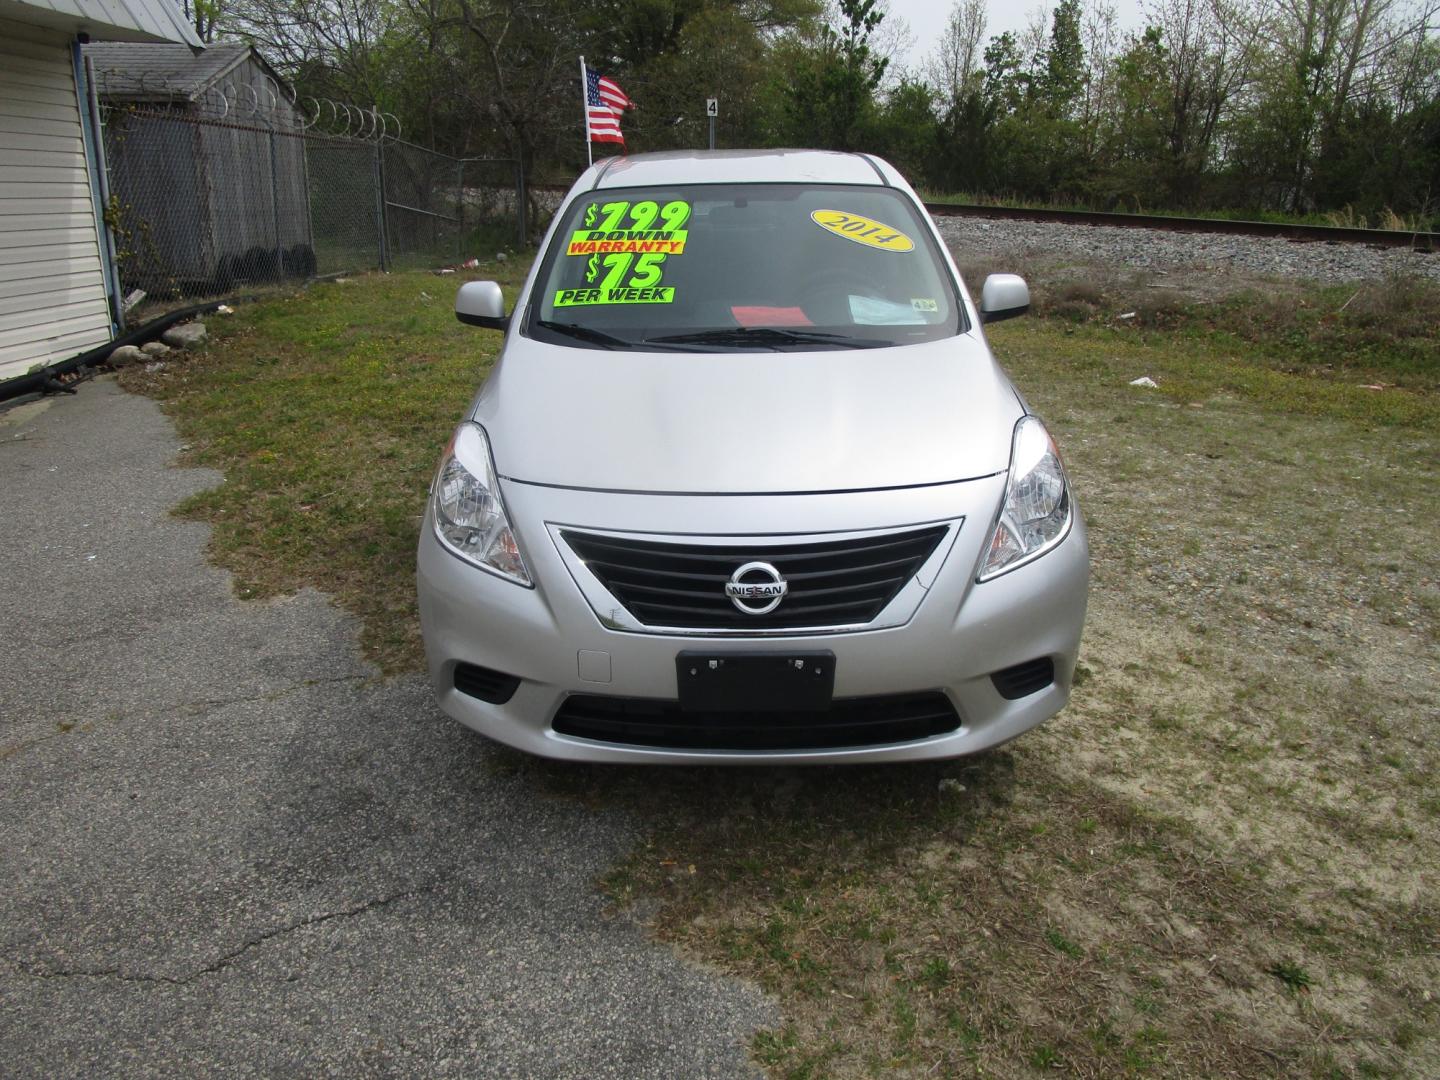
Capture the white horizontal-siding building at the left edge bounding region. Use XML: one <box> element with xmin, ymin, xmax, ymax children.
<box><xmin>0</xmin><ymin>0</ymin><xmax>202</xmax><ymax>380</ymax></box>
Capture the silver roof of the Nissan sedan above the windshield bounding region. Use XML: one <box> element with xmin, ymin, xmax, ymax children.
<box><xmin>579</xmin><ymin>150</ymin><xmax>904</xmax><ymax>190</ymax></box>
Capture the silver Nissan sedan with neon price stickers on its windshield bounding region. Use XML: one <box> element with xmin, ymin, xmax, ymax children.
<box><xmin>418</xmin><ymin>151</ymin><xmax>1089</xmax><ymax>765</ymax></box>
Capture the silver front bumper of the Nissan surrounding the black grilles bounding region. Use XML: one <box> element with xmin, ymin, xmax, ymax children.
<box><xmin>418</xmin><ymin>475</ymin><xmax>1089</xmax><ymax>765</ymax></box>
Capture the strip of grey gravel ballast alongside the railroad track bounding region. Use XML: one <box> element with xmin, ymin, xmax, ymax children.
<box><xmin>936</xmin><ymin>217</ymin><xmax>1440</xmax><ymax>282</ymax></box>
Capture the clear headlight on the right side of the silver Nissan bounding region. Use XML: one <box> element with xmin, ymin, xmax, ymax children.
<box><xmin>979</xmin><ymin>416</ymin><xmax>1070</xmax><ymax>582</ymax></box>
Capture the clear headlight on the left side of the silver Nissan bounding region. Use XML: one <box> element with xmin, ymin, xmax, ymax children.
<box><xmin>431</xmin><ymin>423</ymin><xmax>530</xmax><ymax>585</ymax></box>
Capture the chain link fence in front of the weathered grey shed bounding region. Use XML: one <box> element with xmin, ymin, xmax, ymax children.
<box><xmin>102</xmin><ymin>99</ymin><xmax>526</xmax><ymax>300</ymax></box>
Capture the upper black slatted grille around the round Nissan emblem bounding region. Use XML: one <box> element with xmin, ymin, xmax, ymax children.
<box><xmin>562</xmin><ymin>526</ymin><xmax>946</xmax><ymax>631</ymax></box>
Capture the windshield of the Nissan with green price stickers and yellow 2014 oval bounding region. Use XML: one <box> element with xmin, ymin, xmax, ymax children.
<box><xmin>526</xmin><ymin>184</ymin><xmax>965</xmax><ymax>351</ymax></box>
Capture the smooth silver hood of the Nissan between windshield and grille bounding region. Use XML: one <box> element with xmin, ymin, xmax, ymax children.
<box><xmin>474</xmin><ymin>334</ymin><xmax>1022</xmax><ymax>494</ymax></box>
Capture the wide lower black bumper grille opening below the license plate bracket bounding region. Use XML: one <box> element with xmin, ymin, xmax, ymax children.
<box><xmin>552</xmin><ymin>691</ymin><xmax>960</xmax><ymax>750</ymax></box>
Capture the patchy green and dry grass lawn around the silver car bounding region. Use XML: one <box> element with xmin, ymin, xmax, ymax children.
<box><xmin>115</xmin><ymin>262</ymin><xmax>1440</xmax><ymax>1077</ymax></box>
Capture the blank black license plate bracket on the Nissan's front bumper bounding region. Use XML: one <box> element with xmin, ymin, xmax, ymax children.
<box><xmin>675</xmin><ymin>649</ymin><xmax>835</xmax><ymax>713</ymax></box>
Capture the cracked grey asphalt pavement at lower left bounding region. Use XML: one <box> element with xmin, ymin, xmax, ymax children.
<box><xmin>0</xmin><ymin>380</ymin><xmax>778</xmax><ymax>1079</ymax></box>
